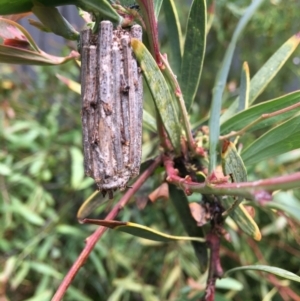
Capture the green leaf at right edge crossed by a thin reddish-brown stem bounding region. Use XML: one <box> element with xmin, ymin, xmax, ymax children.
<box><xmin>221</xmin><ymin>91</ymin><xmax>300</xmax><ymax>134</ymax></box>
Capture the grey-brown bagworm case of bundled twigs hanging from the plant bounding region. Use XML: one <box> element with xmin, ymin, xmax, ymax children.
<box><xmin>81</xmin><ymin>21</ymin><xmax>143</xmax><ymax>194</ymax></box>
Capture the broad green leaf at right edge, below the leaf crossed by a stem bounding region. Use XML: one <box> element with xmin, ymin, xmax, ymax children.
<box><xmin>242</xmin><ymin>116</ymin><xmax>300</xmax><ymax>165</ymax></box>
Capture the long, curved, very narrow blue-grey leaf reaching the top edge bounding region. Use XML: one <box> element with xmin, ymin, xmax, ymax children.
<box><xmin>209</xmin><ymin>0</ymin><xmax>264</xmax><ymax>172</ymax></box>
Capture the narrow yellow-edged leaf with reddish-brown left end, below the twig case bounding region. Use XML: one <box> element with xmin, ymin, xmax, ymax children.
<box><xmin>82</xmin><ymin>218</ymin><xmax>205</xmax><ymax>243</ymax></box>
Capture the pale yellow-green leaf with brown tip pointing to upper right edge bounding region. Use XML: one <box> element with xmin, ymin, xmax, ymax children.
<box><xmin>221</xmin><ymin>33</ymin><xmax>300</xmax><ymax>123</ymax></box>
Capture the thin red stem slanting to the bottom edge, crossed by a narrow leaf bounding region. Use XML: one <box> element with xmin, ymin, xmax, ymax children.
<box><xmin>51</xmin><ymin>156</ymin><xmax>161</xmax><ymax>301</ymax></box>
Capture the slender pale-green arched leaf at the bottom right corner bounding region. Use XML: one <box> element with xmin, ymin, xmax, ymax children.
<box><xmin>224</xmin><ymin>265</ymin><xmax>300</xmax><ymax>282</ymax></box>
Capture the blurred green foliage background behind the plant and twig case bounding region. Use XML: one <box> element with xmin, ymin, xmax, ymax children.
<box><xmin>0</xmin><ymin>0</ymin><xmax>300</xmax><ymax>301</ymax></box>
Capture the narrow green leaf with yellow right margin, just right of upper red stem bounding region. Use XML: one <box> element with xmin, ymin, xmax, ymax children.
<box><xmin>163</xmin><ymin>0</ymin><xmax>182</xmax><ymax>74</ymax></box>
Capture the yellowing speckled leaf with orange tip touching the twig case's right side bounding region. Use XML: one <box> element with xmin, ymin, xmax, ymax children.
<box><xmin>131</xmin><ymin>39</ymin><xmax>181</xmax><ymax>151</ymax></box>
